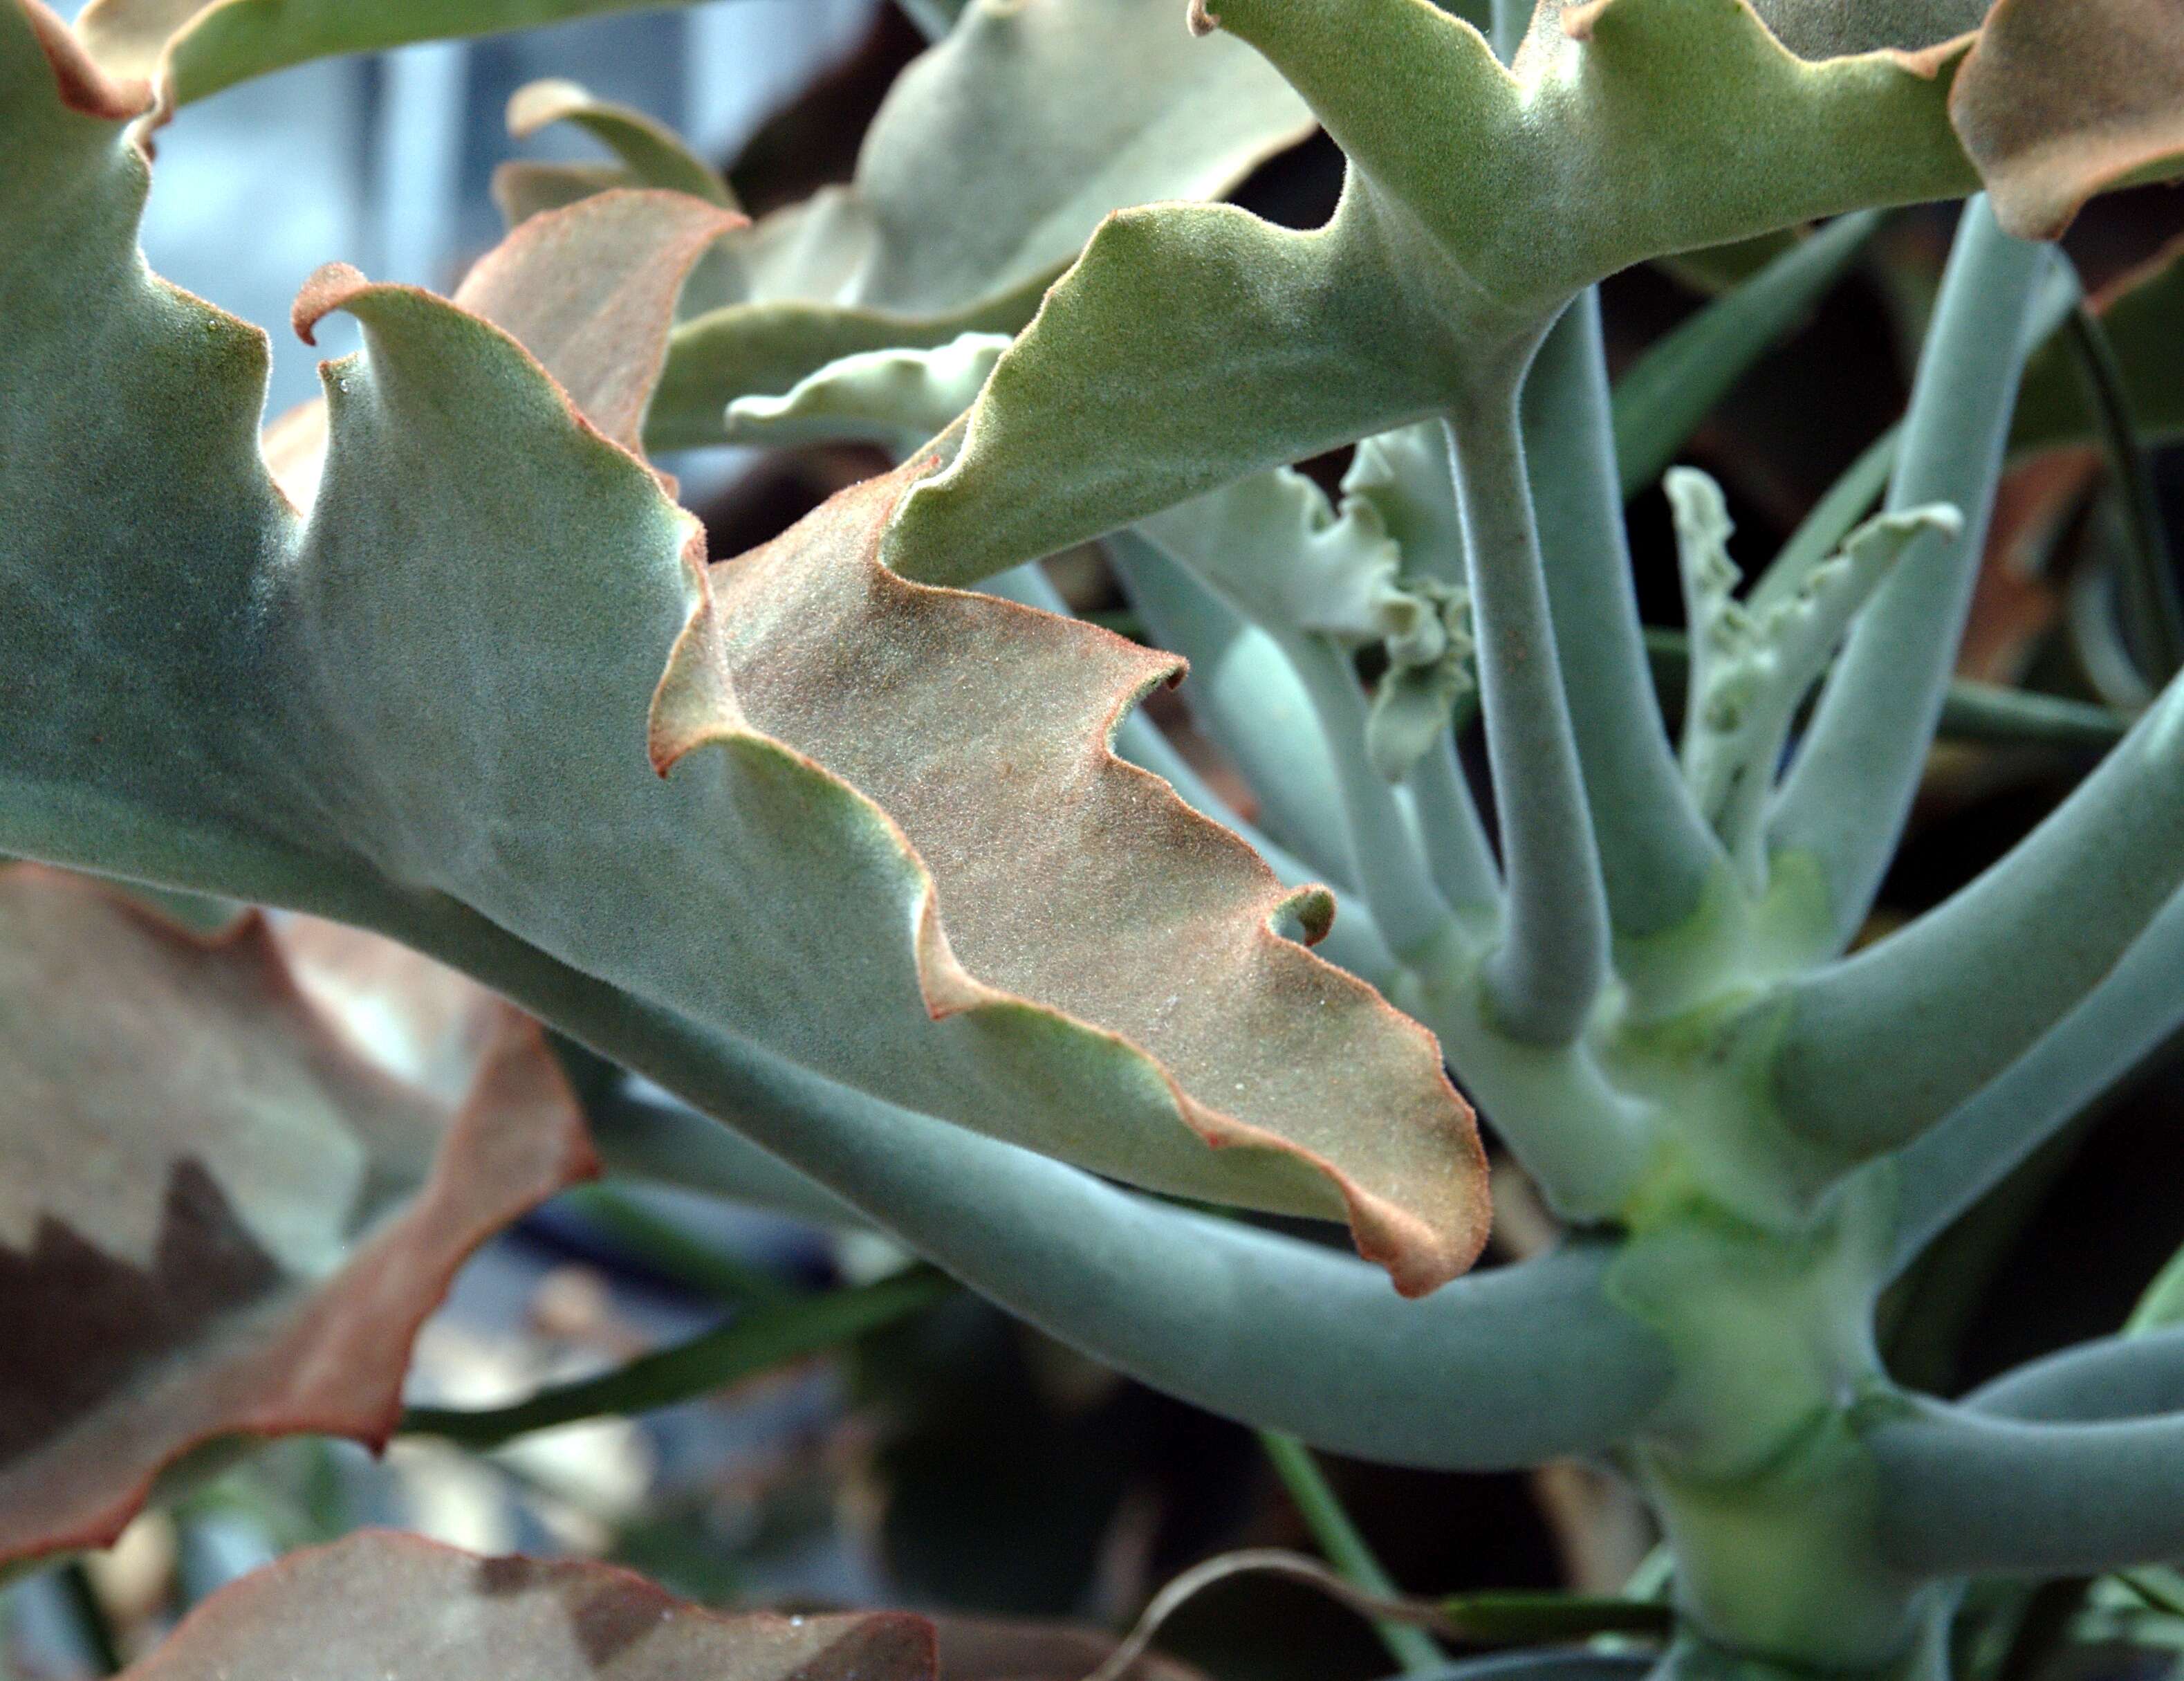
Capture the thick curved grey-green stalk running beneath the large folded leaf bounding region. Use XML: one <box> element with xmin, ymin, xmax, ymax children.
<box><xmin>349</xmin><ymin>899</ymin><xmax>1669</xmax><ymax>1471</ymax></box>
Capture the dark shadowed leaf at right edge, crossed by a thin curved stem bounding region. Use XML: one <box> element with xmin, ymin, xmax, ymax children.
<box><xmin>2009</xmin><ymin>241</ymin><xmax>2184</xmax><ymax>450</ymax></box>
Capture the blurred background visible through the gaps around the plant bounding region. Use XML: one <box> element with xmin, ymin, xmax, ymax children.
<box><xmin>12</xmin><ymin>0</ymin><xmax>2184</xmax><ymax>1681</ymax></box>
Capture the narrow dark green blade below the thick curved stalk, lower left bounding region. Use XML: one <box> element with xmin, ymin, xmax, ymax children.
<box><xmin>402</xmin><ymin>1272</ymin><xmax>952</xmax><ymax>1449</ymax></box>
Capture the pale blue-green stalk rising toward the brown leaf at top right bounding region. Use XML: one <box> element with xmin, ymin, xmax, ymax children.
<box><xmin>1769</xmin><ymin>196</ymin><xmax>2051</xmax><ymax>951</ymax></box>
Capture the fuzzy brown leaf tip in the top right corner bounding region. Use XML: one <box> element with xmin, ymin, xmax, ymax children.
<box><xmin>1950</xmin><ymin>0</ymin><xmax>2184</xmax><ymax>238</ymax></box>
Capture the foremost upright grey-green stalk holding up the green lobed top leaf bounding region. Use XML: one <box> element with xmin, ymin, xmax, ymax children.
<box><xmin>1448</xmin><ymin>367</ymin><xmax>1607</xmax><ymax>1045</ymax></box>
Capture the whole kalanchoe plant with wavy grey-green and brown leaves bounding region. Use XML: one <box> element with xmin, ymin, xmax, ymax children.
<box><xmin>0</xmin><ymin>0</ymin><xmax>2184</xmax><ymax>1677</ymax></box>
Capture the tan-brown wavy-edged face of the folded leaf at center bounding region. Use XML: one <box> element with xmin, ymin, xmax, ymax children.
<box><xmin>653</xmin><ymin>450</ymin><xmax>1483</xmax><ymax>1289</ymax></box>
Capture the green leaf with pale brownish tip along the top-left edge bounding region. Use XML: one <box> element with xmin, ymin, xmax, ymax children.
<box><xmin>77</xmin><ymin>0</ymin><xmax>721</xmax><ymax>105</ymax></box>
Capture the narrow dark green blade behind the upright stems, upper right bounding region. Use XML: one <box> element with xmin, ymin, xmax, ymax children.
<box><xmin>1614</xmin><ymin>210</ymin><xmax>1880</xmax><ymax>501</ymax></box>
